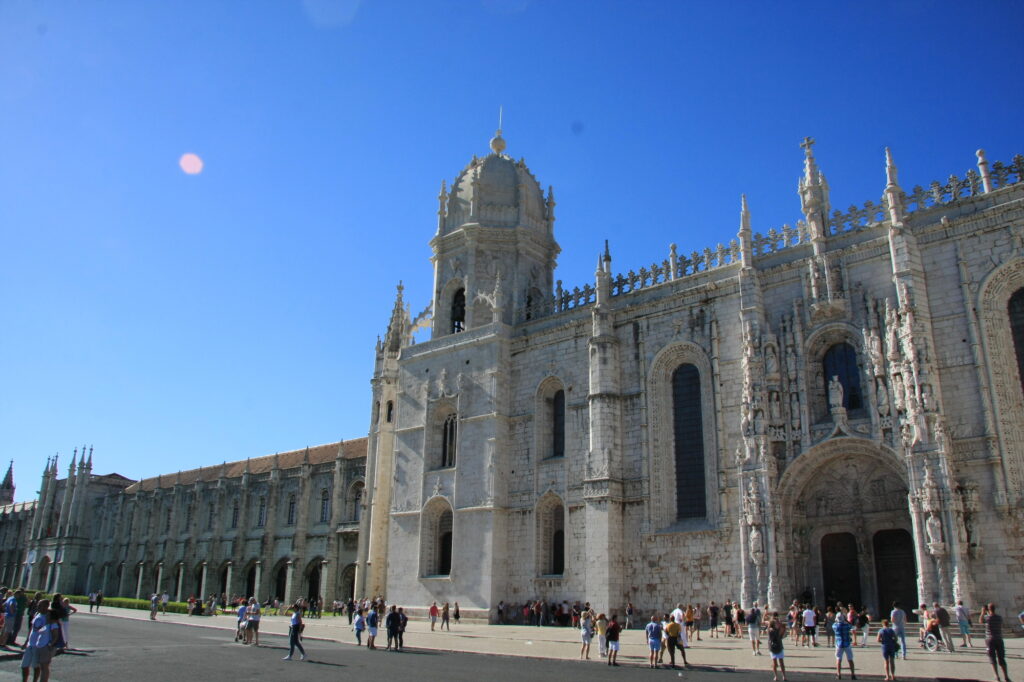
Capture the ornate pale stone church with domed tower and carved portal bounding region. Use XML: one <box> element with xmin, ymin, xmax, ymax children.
<box><xmin>355</xmin><ymin>131</ymin><xmax>1024</xmax><ymax>614</ymax></box>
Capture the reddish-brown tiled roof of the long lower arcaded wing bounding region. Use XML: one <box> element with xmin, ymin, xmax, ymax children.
<box><xmin>125</xmin><ymin>438</ymin><xmax>367</xmax><ymax>494</ymax></box>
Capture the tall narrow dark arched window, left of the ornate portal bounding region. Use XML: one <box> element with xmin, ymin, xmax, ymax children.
<box><xmin>672</xmin><ymin>365</ymin><xmax>708</xmax><ymax>519</ymax></box>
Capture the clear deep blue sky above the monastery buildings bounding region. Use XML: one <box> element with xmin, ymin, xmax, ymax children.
<box><xmin>0</xmin><ymin>0</ymin><xmax>1024</xmax><ymax>500</ymax></box>
